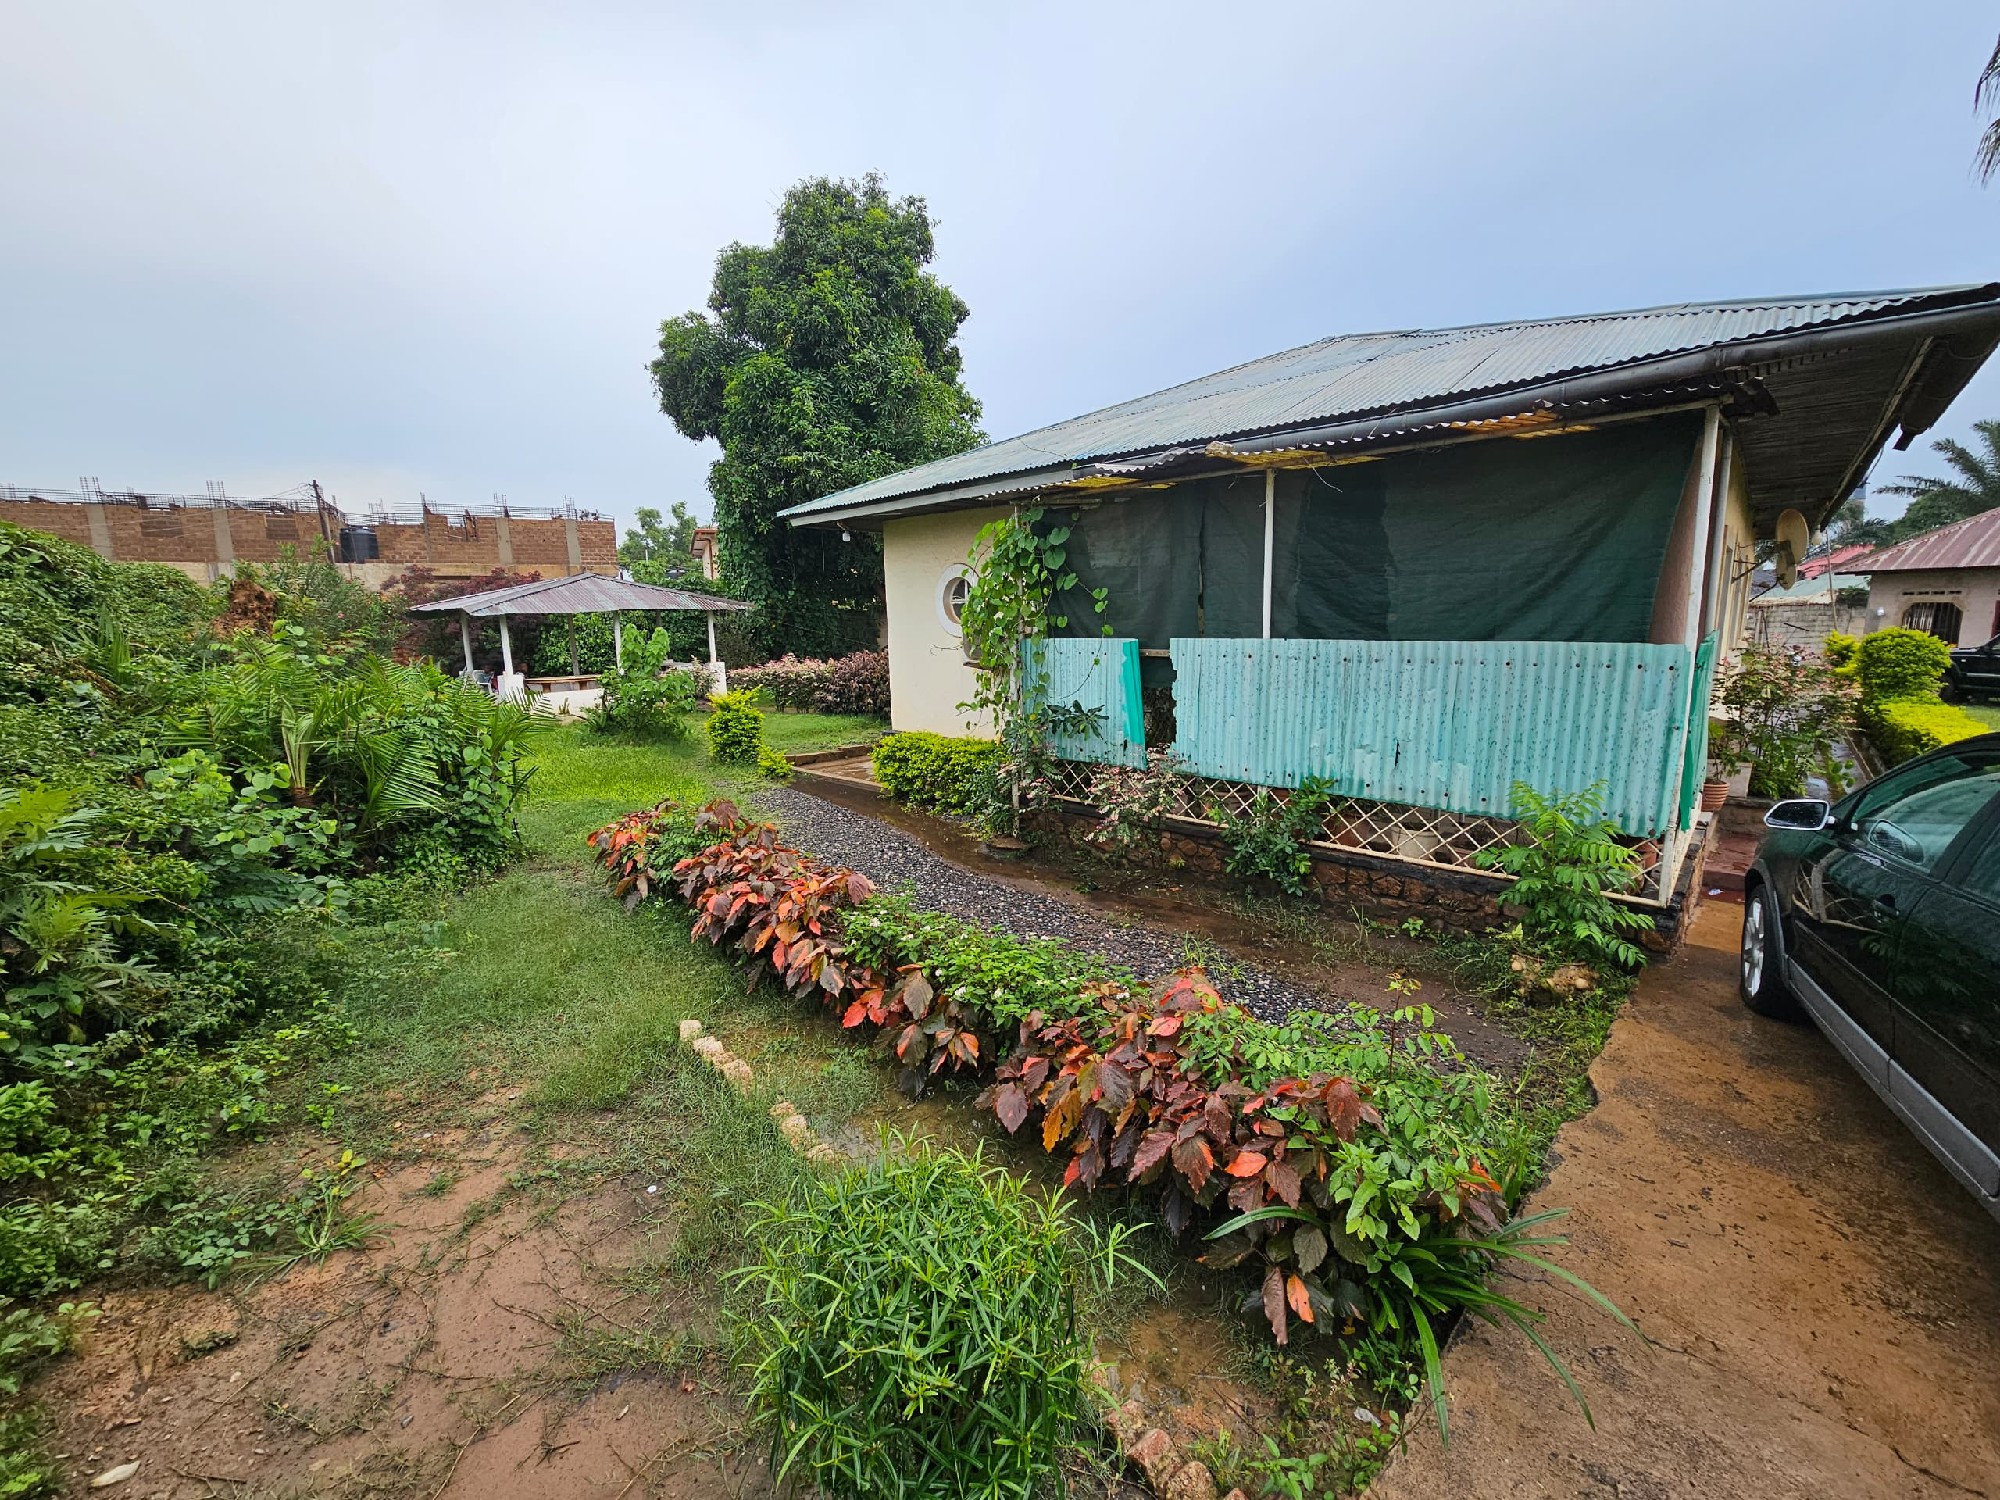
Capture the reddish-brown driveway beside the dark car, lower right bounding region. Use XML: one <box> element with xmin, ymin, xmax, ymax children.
<box><xmin>1372</xmin><ymin>902</ymin><xmax>2000</xmax><ymax>1500</ymax></box>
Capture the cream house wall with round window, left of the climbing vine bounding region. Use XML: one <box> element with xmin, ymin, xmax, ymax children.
<box><xmin>882</xmin><ymin>508</ymin><xmax>1006</xmax><ymax>734</ymax></box>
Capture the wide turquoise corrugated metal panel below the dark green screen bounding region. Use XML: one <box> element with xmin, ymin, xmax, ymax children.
<box><xmin>1172</xmin><ymin>640</ymin><xmax>1692</xmax><ymax>836</ymax></box>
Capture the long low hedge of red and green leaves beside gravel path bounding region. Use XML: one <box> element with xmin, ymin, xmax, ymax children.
<box><xmin>594</xmin><ymin>804</ymin><xmax>1524</xmax><ymax>1342</ymax></box>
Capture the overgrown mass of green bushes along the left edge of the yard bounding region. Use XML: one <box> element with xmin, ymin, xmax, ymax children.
<box><xmin>0</xmin><ymin>524</ymin><xmax>528</xmax><ymax>1298</ymax></box>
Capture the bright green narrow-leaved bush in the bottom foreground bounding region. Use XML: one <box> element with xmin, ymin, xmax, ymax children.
<box><xmin>734</xmin><ymin>1140</ymin><xmax>1092</xmax><ymax>1500</ymax></box>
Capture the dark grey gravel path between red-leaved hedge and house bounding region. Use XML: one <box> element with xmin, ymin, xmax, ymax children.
<box><xmin>758</xmin><ymin>786</ymin><xmax>1320</xmax><ymax>1020</ymax></box>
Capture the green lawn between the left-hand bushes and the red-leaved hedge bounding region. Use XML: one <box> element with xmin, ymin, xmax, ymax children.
<box><xmin>350</xmin><ymin>714</ymin><xmax>904</xmax><ymax>1122</ymax></box>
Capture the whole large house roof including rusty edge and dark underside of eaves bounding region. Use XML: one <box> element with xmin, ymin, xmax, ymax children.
<box><xmin>782</xmin><ymin>284</ymin><xmax>2000</xmax><ymax>530</ymax></box>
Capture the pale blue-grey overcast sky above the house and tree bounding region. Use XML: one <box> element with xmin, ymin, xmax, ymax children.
<box><xmin>0</xmin><ymin>0</ymin><xmax>2000</xmax><ymax>536</ymax></box>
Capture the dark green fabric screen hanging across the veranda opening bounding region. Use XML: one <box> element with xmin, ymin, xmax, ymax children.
<box><xmin>1048</xmin><ymin>412</ymin><xmax>1700</xmax><ymax>648</ymax></box>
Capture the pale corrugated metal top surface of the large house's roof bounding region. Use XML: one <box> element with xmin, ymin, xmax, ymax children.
<box><xmin>784</xmin><ymin>284</ymin><xmax>1994</xmax><ymax>518</ymax></box>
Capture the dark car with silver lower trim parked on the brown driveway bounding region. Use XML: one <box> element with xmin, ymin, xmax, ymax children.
<box><xmin>1740</xmin><ymin>734</ymin><xmax>2000</xmax><ymax>1218</ymax></box>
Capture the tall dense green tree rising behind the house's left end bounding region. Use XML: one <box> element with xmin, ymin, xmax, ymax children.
<box><xmin>652</xmin><ymin>174</ymin><xmax>984</xmax><ymax>654</ymax></box>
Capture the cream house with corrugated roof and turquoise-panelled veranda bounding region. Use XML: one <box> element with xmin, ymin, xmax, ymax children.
<box><xmin>784</xmin><ymin>284</ymin><xmax>2000</xmax><ymax>916</ymax></box>
